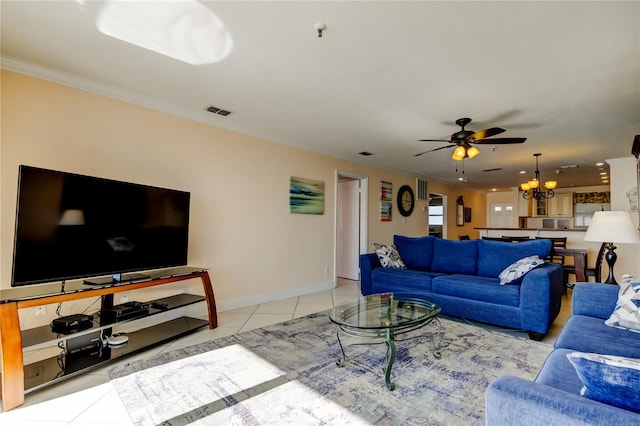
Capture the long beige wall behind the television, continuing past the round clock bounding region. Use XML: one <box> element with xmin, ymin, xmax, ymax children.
<box><xmin>0</xmin><ymin>70</ymin><xmax>486</xmax><ymax>310</ymax></box>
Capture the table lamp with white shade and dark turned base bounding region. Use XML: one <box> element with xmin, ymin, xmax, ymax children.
<box><xmin>584</xmin><ymin>211</ymin><xmax>640</xmax><ymax>284</ymax></box>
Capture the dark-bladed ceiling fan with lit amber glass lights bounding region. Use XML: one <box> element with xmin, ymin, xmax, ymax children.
<box><xmin>415</xmin><ymin>118</ymin><xmax>527</xmax><ymax>160</ymax></box>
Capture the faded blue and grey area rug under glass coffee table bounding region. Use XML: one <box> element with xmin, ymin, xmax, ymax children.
<box><xmin>109</xmin><ymin>313</ymin><xmax>552</xmax><ymax>425</ymax></box>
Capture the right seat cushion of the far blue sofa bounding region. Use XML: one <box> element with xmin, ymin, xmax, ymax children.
<box><xmin>431</xmin><ymin>274</ymin><xmax>520</xmax><ymax>306</ymax></box>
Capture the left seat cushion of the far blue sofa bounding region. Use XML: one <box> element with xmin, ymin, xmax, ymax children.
<box><xmin>371</xmin><ymin>268</ymin><xmax>442</xmax><ymax>293</ymax></box>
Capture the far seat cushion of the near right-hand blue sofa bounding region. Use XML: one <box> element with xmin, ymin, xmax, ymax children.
<box><xmin>554</xmin><ymin>315</ymin><xmax>640</xmax><ymax>358</ymax></box>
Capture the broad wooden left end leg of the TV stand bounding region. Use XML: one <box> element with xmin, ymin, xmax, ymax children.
<box><xmin>0</xmin><ymin>302</ymin><xmax>24</xmax><ymax>411</ymax></box>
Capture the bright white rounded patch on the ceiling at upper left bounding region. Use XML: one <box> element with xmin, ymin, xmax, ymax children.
<box><xmin>96</xmin><ymin>0</ymin><xmax>233</xmax><ymax>65</ymax></box>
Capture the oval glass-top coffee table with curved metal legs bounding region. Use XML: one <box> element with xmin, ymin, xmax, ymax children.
<box><xmin>329</xmin><ymin>293</ymin><xmax>442</xmax><ymax>390</ymax></box>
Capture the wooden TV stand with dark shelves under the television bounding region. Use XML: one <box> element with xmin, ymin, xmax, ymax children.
<box><xmin>0</xmin><ymin>268</ymin><xmax>218</xmax><ymax>411</ymax></box>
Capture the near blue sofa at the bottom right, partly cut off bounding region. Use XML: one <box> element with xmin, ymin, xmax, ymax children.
<box><xmin>485</xmin><ymin>283</ymin><xmax>640</xmax><ymax>426</ymax></box>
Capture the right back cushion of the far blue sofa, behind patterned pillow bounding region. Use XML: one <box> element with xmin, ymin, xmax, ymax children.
<box><xmin>478</xmin><ymin>240</ymin><xmax>551</xmax><ymax>278</ymax></box>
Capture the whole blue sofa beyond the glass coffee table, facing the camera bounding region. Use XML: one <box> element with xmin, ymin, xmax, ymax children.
<box><xmin>360</xmin><ymin>235</ymin><xmax>563</xmax><ymax>340</ymax></box>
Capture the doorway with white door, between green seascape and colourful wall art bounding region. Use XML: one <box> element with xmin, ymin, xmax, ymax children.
<box><xmin>335</xmin><ymin>171</ymin><xmax>368</xmax><ymax>281</ymax></box>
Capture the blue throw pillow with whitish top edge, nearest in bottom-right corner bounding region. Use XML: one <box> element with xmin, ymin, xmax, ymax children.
<box><xmin>567</xmin><ymin>352</ymin><xmax>640</xmax><ymax>413</ymax></box>
